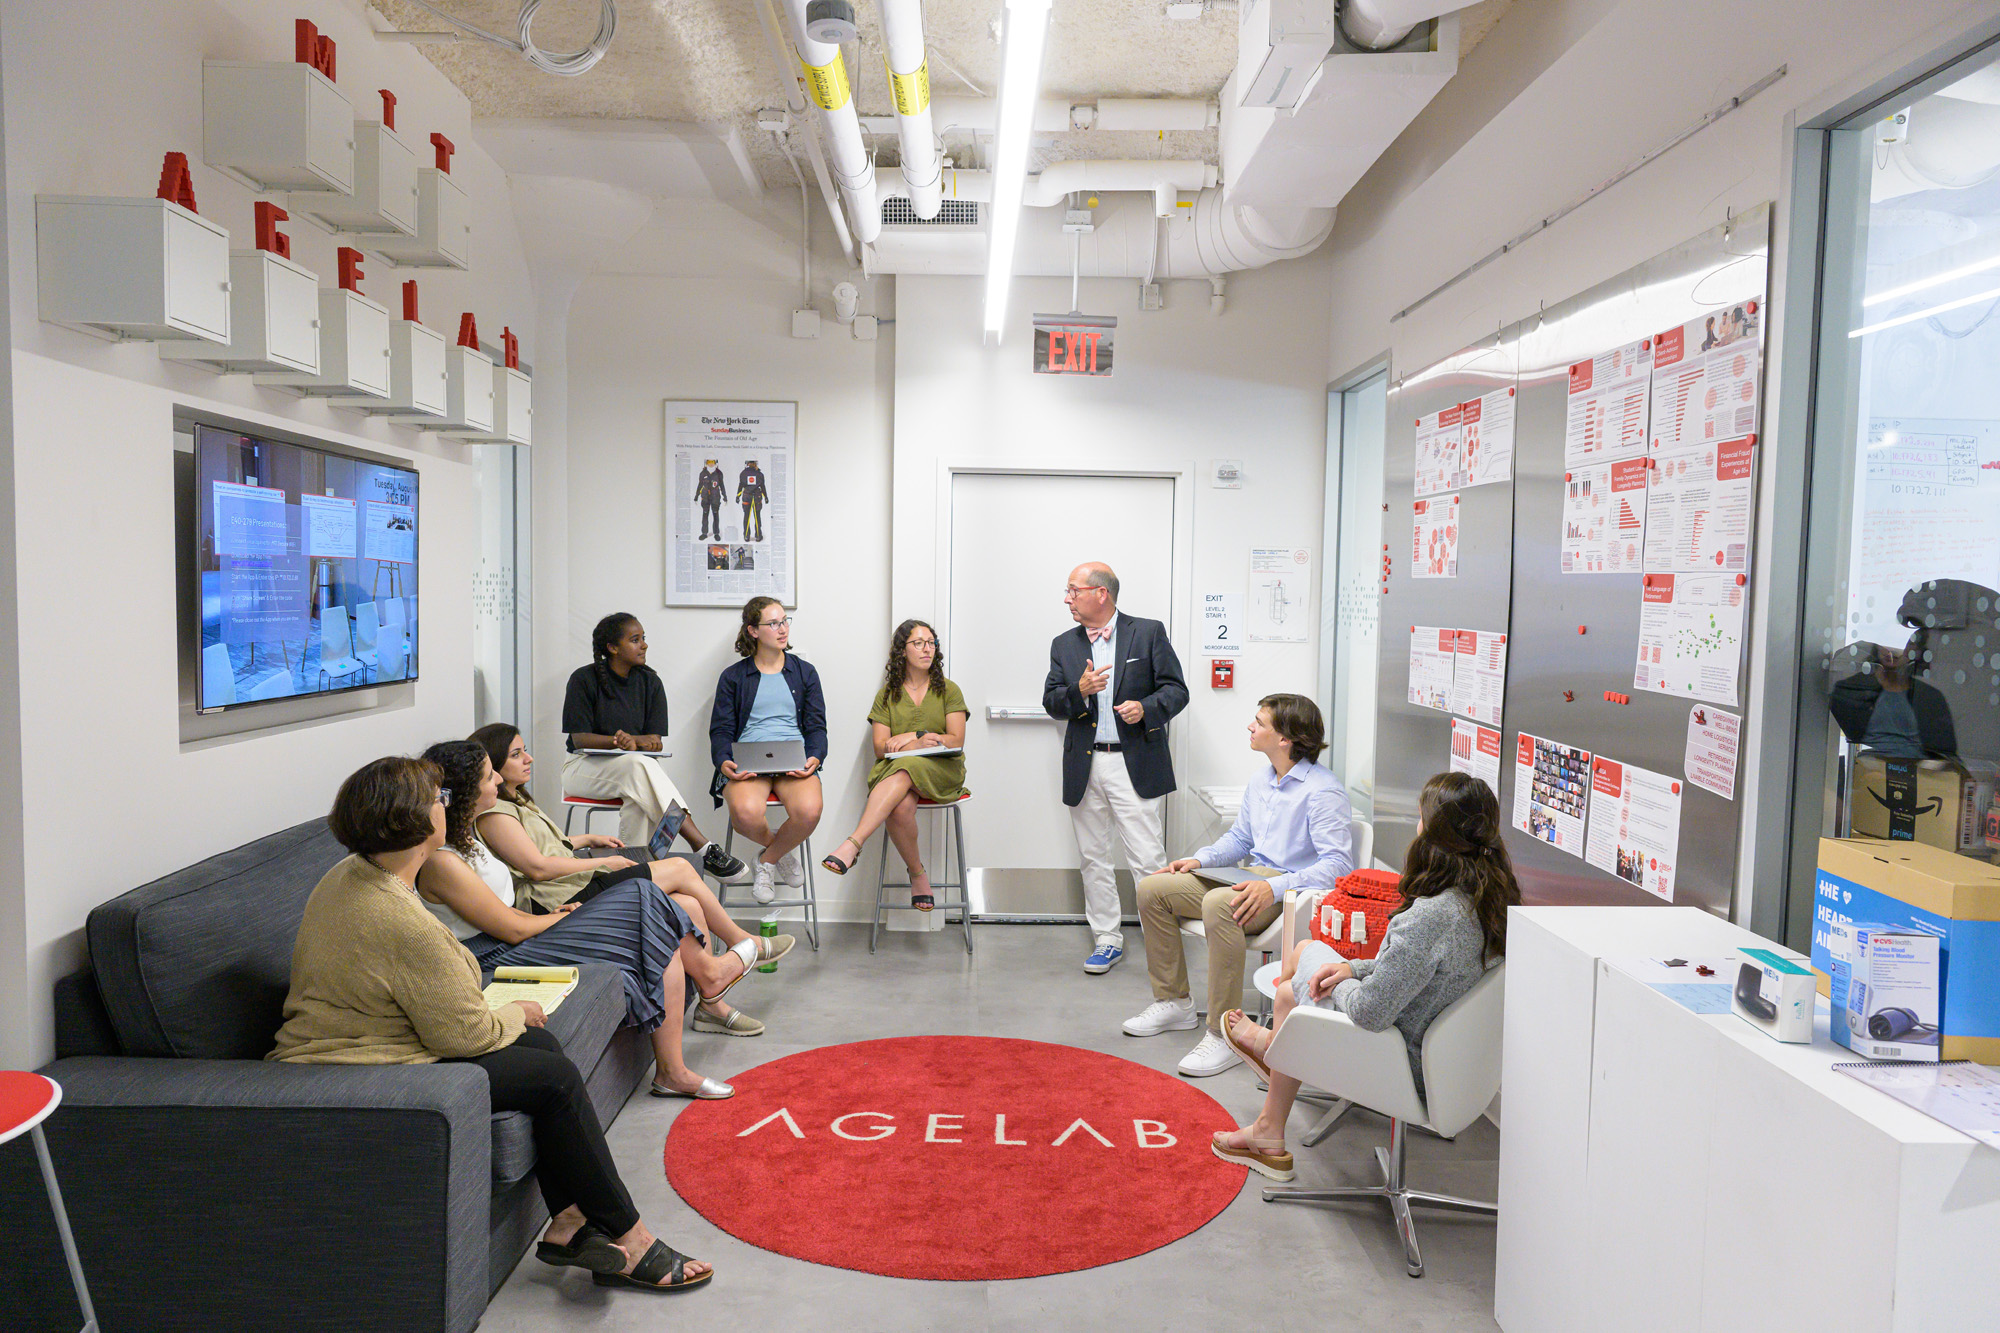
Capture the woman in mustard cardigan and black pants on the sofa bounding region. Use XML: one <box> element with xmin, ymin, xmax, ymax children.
<box><xmin>266</xmin><ymin>759</ymin><xmax>736</xmax><ymax>1291</ymax></box>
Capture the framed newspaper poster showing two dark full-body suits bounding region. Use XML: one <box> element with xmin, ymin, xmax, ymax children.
<box><xmin>666</xmin><ymin>398</ymin><xmax>798</xmax><ymax>606</ymax></box>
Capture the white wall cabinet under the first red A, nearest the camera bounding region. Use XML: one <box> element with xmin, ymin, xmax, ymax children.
<box><xmin>34</xmin><ymin>194</ymin><xmax>230</xmax><ymax>342</ymax></box>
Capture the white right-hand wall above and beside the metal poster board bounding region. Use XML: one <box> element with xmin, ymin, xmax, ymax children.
<box><xmin>1324</xmin><ymin>0</ymin><xmax>1994</xmax><ymax>919</ymax></box>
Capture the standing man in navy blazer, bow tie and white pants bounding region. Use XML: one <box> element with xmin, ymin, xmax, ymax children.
<box><xmin>1042</xmin><ymin>562</ymin><xmax>1188</xmax><ymax>973</ymax></box>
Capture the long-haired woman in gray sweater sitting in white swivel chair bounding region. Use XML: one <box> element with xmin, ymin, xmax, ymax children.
<box><xmin>1212</xmin><ymin>773</ymin><xmax>1520</xmax><ymax>1181</ymax></box>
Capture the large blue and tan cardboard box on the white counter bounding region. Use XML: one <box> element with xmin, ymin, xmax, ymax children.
<box><xmin>1812</xmin><ymin>839</ymin><xmax>2000</xmax><ymax>1065</ymax></box>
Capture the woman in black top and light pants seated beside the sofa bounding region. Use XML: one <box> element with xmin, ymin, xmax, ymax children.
<box><xmin>562</xmin><ymin>610</ymin><xmax>746</xmax><ymax>881</ymax></box>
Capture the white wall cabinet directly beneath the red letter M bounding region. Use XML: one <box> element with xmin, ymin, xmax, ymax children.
<box><xmin>202</xmin><ymin>60</ymin><xmax>354</xmax><ymax>194</ymax></box>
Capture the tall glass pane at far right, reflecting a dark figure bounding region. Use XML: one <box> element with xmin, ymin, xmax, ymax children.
<box><xmin>1788</xmin><ymin>48</ymin><xmax>2000</xmax><ymax>943</ymax></box>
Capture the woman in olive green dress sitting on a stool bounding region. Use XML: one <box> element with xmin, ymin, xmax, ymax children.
<box><xmin>820</xmin><ymin>620</ymin><xmax>966</xmax><ymax>913</ymax></box>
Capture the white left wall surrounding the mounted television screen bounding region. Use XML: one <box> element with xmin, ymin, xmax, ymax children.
<box><xmin>0</xmin><ymin>0</ymin><xmax>534</xmax><ymax>1065</ymax></box>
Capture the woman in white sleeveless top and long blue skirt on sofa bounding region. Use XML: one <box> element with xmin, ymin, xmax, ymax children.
<box><xmin>416</xmin><ymin>741</ymin><xmax>758</xmax><ymax>1099</ymax></box>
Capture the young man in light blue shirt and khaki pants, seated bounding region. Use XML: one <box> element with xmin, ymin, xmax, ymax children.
<box><xmin>1124</xmin><ymin>695</ymin><xmax>1354</xmax><ymax>1079</ymax></box>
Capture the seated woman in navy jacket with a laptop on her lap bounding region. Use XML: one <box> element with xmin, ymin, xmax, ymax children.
<box><xmin>708</xmin><ymin>596</ymin><xmax>826</xmax><ymax>903</ymax></box>
